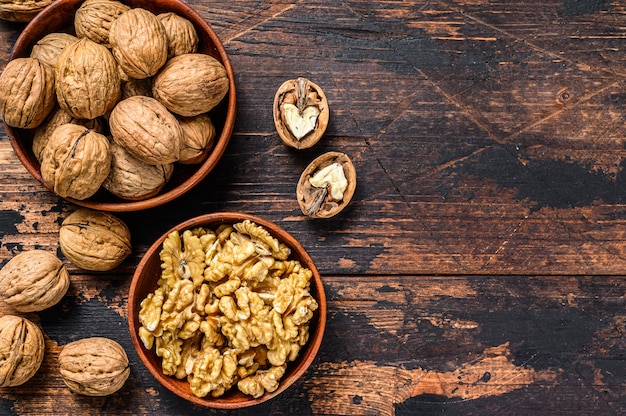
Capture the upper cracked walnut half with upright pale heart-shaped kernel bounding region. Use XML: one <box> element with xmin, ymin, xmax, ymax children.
<box><xmin>273</xmin><ymin>77</ymin><xmax>330</xmax><ymax>149</ymax></box>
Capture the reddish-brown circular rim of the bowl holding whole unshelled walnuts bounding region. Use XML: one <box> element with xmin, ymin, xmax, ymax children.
<box><xmin>3</xmin><ymin>0</ymin><xmax>237</xmax><ymax>212</ymax></box>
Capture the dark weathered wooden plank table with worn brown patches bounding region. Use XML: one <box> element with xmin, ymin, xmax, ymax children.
<box><xmin>0</xmin><ymin>0</ymin><xmax>626</xmax><ymax>415</ymax></box>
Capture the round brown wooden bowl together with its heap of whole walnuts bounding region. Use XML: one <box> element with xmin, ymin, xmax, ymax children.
<box><xmin>0</xmin><ymin>0</ymin><xmax>235</xmax><ymax>211</ymax></box>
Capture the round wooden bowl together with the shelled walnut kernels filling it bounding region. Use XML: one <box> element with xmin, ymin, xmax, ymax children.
<box><xmin>128</xmin><ymin>213</ymin><xmax>326</xmax><ymax>409</ymax></box>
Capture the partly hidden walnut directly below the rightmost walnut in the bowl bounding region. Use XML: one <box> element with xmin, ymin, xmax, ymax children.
<box><xmin>178</xmin><ymin>114</ymin><xmax>216</xmax><ymax>164</ymax></box>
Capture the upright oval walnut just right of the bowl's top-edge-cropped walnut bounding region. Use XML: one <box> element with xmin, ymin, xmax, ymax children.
<box><xmin>109</xmin><ymin>8</ymin><xmax>168</xmax><ymax>79</ymax></box>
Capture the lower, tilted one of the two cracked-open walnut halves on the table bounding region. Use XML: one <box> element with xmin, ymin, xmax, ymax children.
<box><xmin>296</xmin><ymin>152</ymin><xmax>356</xmax><ymax>218</ymax></box>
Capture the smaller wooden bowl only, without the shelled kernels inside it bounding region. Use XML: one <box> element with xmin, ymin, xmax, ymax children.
<box><xmin>128</xmin><ymin>213</ymin><xmax>326</xmax><ymax>409</ymax></box>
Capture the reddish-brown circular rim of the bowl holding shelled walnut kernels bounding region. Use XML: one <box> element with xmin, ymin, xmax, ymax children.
<box><xmin>127</xmin><ymin>212</ymin><xmax>327</xmax><ymax>410</ymax></box>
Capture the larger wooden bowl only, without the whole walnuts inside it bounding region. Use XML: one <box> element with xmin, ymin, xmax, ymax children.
<box><xmin>5</xmin><ymin>0</ymin><xmax>236</xmax><ymax>212</ymax></box>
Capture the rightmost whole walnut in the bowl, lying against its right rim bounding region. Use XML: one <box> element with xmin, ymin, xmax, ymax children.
<box><xmin>152</xmin><ymin>53</ymin><xmax>229</xmax><ymax>117</ymax></box>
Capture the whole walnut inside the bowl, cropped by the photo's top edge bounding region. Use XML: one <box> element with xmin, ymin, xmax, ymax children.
<box><xmin>74</xmin><ymin>0</ymin><xmax>130</xmax><ymax>47</ymax></box>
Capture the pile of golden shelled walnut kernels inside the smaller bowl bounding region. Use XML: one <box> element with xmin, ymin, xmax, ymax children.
<box><xmin>139</xmin><ymin>220</ymin><xmax>318</xmax><ymax>398</ymax></box>
